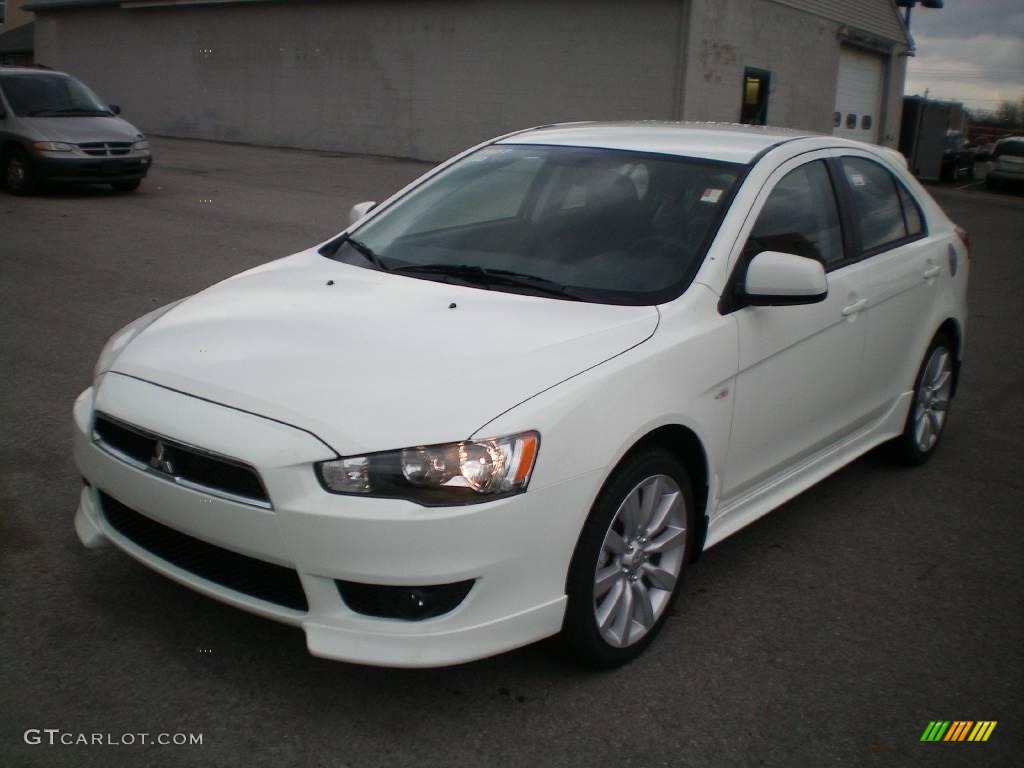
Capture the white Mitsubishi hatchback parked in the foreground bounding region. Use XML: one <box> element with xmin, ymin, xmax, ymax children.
<box><xmin>74</xmin><ymin>123</ymin><xmax>969</xmax><ymax>667</ymax></box>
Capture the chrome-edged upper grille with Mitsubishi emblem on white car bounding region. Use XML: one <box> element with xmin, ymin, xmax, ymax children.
<box><xmin>92</xmin><ymin>413</ymin><xmax>270</xmax><ymax>509</ymax></box>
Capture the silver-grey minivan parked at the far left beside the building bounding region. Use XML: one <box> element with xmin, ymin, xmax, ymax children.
<box><xmin>0</xmin><ymin>67</ymin><xmax>153</xmax><ymax>195</ymax></box>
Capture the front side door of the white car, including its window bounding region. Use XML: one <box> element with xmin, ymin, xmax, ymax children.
<box><xmin>722</xmin><ymin>153</ymin><xmax>869</xmax><ymax>504</ymax></box>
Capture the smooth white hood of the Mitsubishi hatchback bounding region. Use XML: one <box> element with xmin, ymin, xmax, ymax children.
<box><xmin>108</xmin><ymin>251</ymin><xmax>658</xmax><ymax>455</ymax></box>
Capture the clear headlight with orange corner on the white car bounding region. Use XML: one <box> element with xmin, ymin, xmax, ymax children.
<box><xmin>316</xmin><ymin>432</ymin><xmax>541</xmax><ymax>507</ymax></box>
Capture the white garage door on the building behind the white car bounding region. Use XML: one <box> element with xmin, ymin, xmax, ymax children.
<box><xmin>833</xmin><ymin>46</ymin><xmax>885</xmax><ymax>143</ymax></box>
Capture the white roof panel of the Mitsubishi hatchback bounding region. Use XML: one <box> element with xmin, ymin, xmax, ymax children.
<box><xmin>498</xmin><ymin>121</ymin><xmax>831</xmax><ymax>164</ymax></box>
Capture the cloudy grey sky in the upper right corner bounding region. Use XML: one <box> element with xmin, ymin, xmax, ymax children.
<box><xmin>906</xmin><ymin>0</ymin><xmax>1024</xmax><ymax>110</ymax></box>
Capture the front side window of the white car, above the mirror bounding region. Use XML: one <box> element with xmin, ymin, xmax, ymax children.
<box><xmin>743</xmin><ymin>160</ymin><xmax>845</xmax><ymax>268</ymax></box>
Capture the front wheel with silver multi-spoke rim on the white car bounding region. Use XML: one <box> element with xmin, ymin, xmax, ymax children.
<box><xmin>562</xmin><ymin>449</ymin><xmax>696</xmax><ymax>669</ymax></box>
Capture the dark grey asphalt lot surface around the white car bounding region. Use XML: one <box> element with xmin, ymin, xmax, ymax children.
<box><xmin>0</xmin><ymin>139</ymin><xmax>1024</xmax><ymax>768</ymax></box>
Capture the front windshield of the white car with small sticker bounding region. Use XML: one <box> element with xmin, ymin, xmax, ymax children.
<box><xmin>321</xmin><ymin>144</ymin><xmax>741</xmax><ymax>304</ymax></box>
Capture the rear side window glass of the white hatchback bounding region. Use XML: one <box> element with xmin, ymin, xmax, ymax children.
<box><xmin>842</xmin><ymin>158</ymin><xmax>923</xmax><ymax>251</ymax></box>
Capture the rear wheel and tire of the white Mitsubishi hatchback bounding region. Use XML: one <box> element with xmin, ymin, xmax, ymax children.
<box><xmin>889</xmin><ymin>334</ymin><xmax>956</xmax><ymax>467</ymax></box>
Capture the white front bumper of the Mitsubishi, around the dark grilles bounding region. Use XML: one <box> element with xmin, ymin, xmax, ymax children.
<box><xmin>75</xmin><ymin>374</ymin><xmax>600</xmax><ymax>667</ymax></box>
